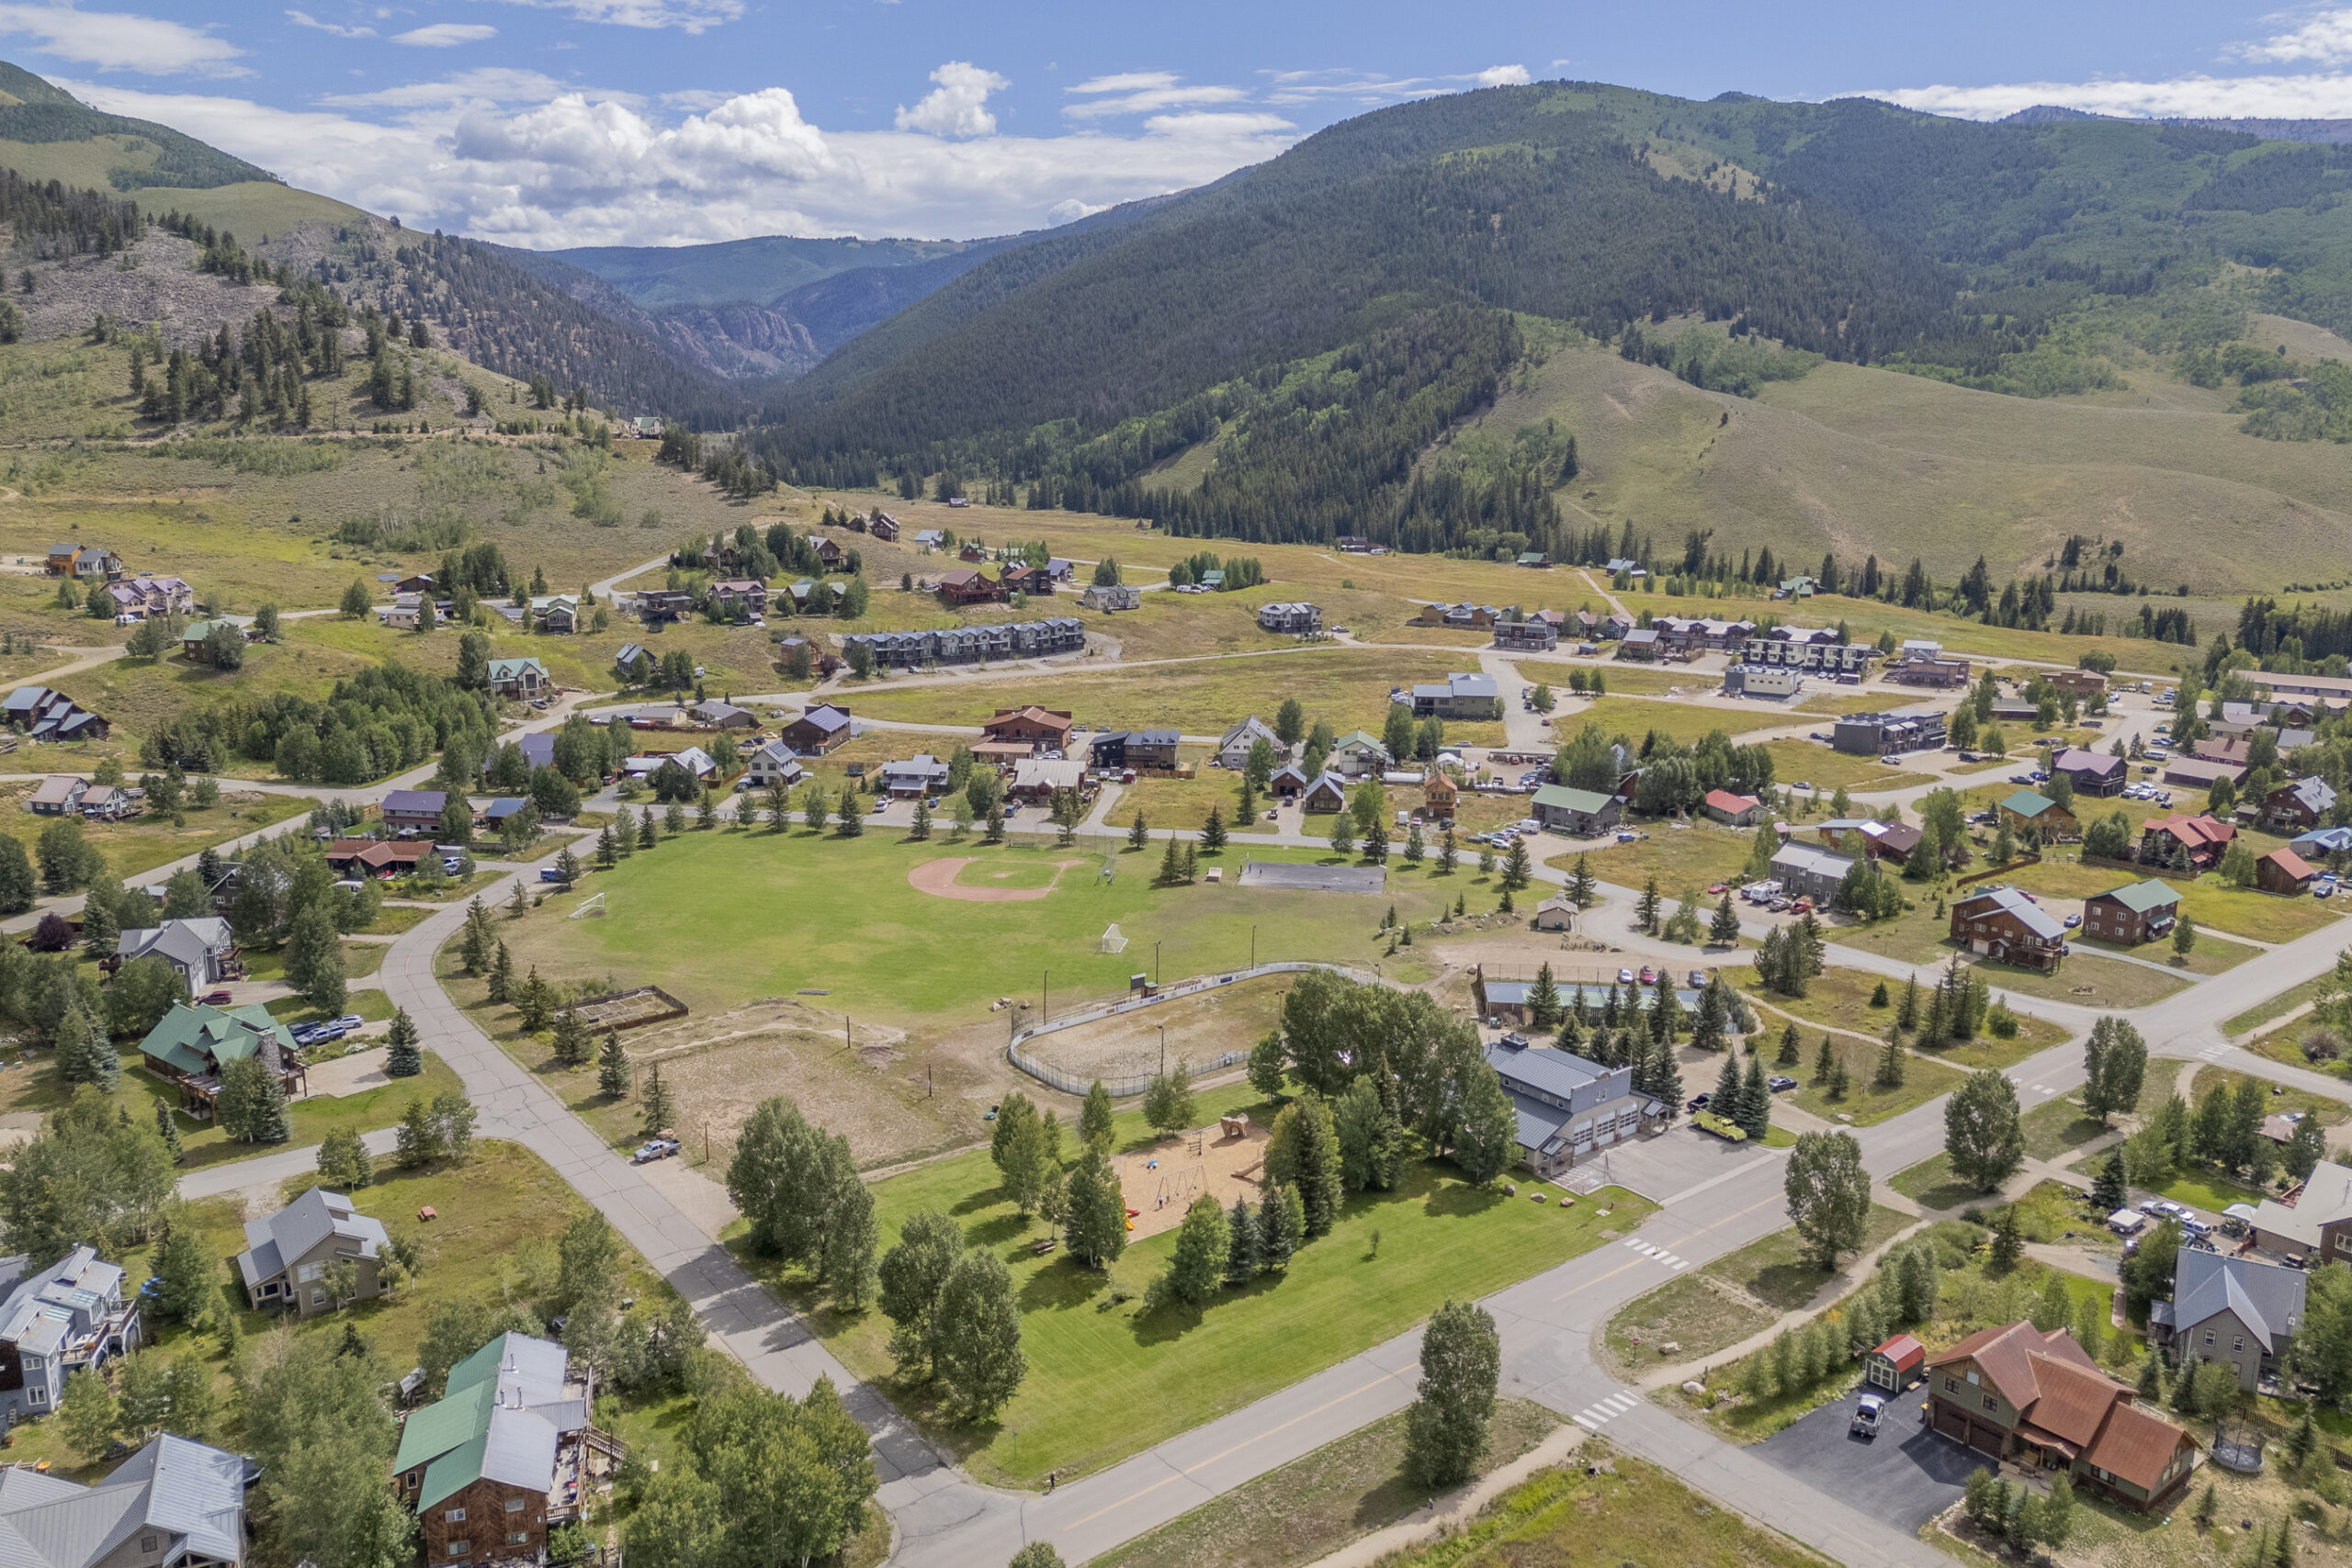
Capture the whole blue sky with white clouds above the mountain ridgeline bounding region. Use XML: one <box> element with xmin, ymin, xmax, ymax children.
<box><xmin>14</xmin><ymin>0</ymin><xmax>2352</xmax><ymax>247</ymax></box>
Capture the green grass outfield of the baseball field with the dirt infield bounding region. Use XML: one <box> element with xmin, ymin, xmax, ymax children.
<box><xmin>499</xmin><ymin>828</ymin><xmax>1458</xmax><ymax>1018</ymax></box>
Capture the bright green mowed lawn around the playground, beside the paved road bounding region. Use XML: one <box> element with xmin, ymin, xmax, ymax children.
<box><xmin>746</xmin><ymin>1086</ymin><xmax>1651</xmax><ymax>1485</ymax></box>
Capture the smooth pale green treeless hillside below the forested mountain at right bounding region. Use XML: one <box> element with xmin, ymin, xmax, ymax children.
<box><xmin>1479</xmin><ymin>348</ymin><xmax>2352</xmax><ymax>592</ymax></box>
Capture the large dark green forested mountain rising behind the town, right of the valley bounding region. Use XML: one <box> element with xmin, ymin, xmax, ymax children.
<box><xmin>755</xmin><ymin>83</ymin><xmax>2352</xmax><ymax>557</ymax></box>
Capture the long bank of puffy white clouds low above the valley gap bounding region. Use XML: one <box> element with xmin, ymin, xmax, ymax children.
<box><xmin>68</xmin><ymin>73</ymin><xmax>1296</xmax><ymax>249</ymax></box>
